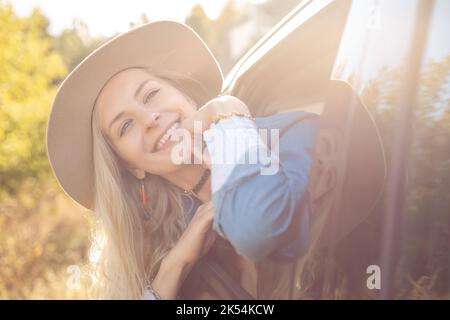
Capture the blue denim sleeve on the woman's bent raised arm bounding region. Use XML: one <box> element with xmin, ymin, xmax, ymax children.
<box><xmin>209</xmin><ymin>117</ymin><xmax>318</xmax><ymax>261</ymax></box>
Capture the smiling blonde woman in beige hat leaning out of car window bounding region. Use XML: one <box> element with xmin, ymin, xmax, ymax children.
<box><xmin>47</xmin><ymin>21</ymin><xmax>384</xmax><ymax>299</ymax></box>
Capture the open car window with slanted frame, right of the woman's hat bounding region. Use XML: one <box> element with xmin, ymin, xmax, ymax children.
<box><xmin>225</xmin><ymin>0</ymin><xmax>351</xmax><ymax>116</ymax></box>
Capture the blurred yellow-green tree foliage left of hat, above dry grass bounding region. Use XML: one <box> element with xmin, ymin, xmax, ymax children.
<box><xmin>0</xmin><ymin>4</ymin><xmax>67</xmax><ymax>197</ymax></box>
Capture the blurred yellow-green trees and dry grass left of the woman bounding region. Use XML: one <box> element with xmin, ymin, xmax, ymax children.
<box><xmin>0</xmin><ymin>1</ymin><xmax>97</xmax><ymax>299</ymax></box>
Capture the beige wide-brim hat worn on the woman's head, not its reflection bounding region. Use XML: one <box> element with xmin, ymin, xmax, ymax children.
<box><xmin>47</xmin><ymin>21</ymin><xmax>223</xmax><ymax>210</ymax></box>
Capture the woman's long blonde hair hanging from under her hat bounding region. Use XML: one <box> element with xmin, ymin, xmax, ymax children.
<box><xmin>89</xmin><ymin>68</ymin><xmax>211</xmax><ymax>299</ymax></box>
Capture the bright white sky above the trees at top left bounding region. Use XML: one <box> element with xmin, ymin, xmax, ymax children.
<box><xmin>12</xmin><ymin>0</ymin><xmax>261</xmax><ymax>37</ymax></box>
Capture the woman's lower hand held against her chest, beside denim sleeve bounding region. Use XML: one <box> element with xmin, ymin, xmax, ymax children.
<box><xmin>169</xmin><ymin>201</ymin><xmax>217</xmax><ymax>265</ymax></box>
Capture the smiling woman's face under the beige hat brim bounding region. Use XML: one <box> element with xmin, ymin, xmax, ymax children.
<box><xmin>95</xmin><ymin>69</ymin><xmax>197</xmax><ymax>179</ymax></box>
